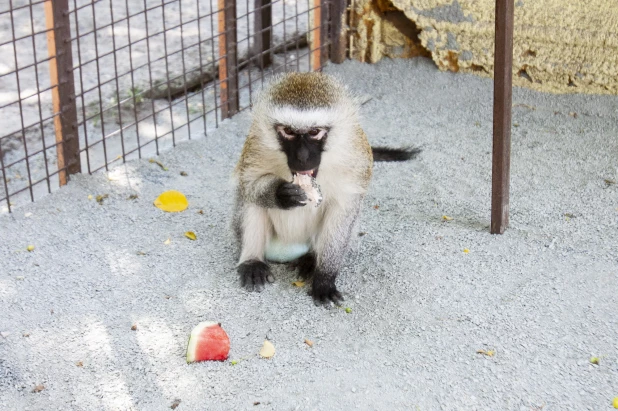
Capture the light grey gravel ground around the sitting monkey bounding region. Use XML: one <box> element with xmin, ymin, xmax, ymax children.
<box><xmin>0</xmin><ymin>59</ymin><xmax>618</xmax><ymax>410</ymax></box>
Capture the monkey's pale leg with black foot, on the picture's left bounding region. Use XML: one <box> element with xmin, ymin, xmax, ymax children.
<box><xmin>238</xmin><ymin>205</ymin><xmax>275</xmax><ymax>291</ymax></box>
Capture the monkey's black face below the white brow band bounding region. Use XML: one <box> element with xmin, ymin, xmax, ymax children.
<box><xmin>275</xmin><ymin>125</ymin><xmax>328</xmax><ymax>177</ymax></box>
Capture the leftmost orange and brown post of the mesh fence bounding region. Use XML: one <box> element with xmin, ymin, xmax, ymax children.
<box><xmin>45</xmin><ymin>0</ymin><xmax>81</xmax><ymax>186</ymax></box>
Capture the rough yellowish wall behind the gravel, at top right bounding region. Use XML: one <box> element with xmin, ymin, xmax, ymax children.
<box><xmin>351</xmin><ymin>0</ymin><xmax>618</xmax><ymax>94</ymax></box>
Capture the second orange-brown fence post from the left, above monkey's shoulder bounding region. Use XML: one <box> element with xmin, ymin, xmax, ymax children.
<box><xmin>218</xmin><ymin>0</ymin><xmax>238</xmax><ymax>119</ymax></box>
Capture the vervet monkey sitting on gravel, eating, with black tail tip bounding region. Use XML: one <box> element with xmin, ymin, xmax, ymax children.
<box><xmin>233</xmin><ymin>72</ymin><xmax>419</xmax><ymax>304</ymax></box>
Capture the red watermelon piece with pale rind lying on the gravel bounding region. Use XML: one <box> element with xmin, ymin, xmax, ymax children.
<box><xmin>187</xmin><ymin>321</ymin><xmax>230</xmax><ymax>363</ymax></box>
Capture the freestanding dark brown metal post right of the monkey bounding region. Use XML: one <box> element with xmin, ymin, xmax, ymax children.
<box><xmin>491</xmin><ymin>0</ymin><xmax>514</xmax><ymax>234</ymax></box>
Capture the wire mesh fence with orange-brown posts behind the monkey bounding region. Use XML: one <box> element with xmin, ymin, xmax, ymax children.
<box><xmin>0</xmin><ymin>0</ymin><xmax>346</xmax><ymax>212</ymax></box>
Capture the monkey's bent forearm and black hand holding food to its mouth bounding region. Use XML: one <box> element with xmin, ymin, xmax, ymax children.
<box><xmin>241</xmin><ymin>174</ymin><xmax>307</xmax><ymax>210</ymax></box>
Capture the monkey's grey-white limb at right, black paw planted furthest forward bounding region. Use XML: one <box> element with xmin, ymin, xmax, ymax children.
<box><xmin>311</xmin><ymin>199</ymin><xmax>361</xmax><ymax>304</ymax></box>
